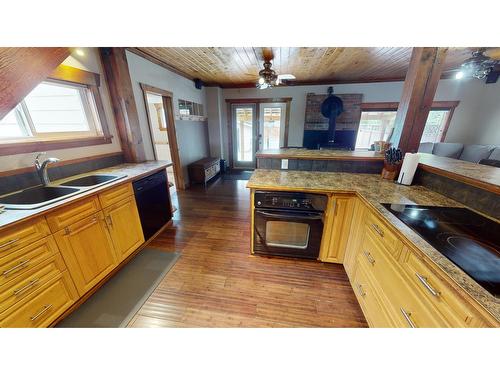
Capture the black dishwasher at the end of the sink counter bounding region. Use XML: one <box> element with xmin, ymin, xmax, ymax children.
<box><xmin>133</xmin><ymin>170</ymin><xmax>172</xmax><ymax>241</ymax></box>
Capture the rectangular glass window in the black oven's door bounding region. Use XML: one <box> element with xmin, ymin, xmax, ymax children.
<box><xmin>266</xmin><ymin>221</ymin><xmax>310</xmax><ymax>249</ymax></box>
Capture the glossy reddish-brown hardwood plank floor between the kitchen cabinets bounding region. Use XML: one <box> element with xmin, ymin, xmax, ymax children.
<box><xmin>129</xmin><ymin>180</ymin><xmax>366</xmax><ymax>327</ymax></box>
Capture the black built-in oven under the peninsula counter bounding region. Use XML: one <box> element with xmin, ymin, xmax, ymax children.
<box><xmin>253</xmin><ymin>191</ymin><xmax>328</xmax><ymax>259</ymax></box>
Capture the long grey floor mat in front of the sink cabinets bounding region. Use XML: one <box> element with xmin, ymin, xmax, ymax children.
<box><xmin>57</xmin><ymin>248</ymin><xmax>180</xmax><ymax>328</ymax></box>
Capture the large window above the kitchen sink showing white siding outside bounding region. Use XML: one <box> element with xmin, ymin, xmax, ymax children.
<box><xmin>0</xmin><ymin>81</ymin><xmax>103</xmax><ymax>141</ymax></box>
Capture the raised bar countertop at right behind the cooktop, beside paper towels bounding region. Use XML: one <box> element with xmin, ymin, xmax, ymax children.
<box><xmin>418</xmin><ymin>153</ymin><xmax>500</xmax><ymax>194</ymax></box>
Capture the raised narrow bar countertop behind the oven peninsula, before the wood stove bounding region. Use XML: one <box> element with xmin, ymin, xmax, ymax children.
<box><xmin>255</xmin><ymin>148</ymin><xmax>384</xmax><ymax>161</ymax></box>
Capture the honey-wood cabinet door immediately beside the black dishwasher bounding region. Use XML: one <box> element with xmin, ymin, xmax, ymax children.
<box><xmin>104</xmin><ymin>196</ymin><xmax>144</xmax><ymax>261</ymax></box>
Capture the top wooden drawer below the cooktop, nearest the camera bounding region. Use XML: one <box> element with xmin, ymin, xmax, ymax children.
<box><xmin>402</xmin><ymin>248</ymin><xmax>482</xmax><ymax>327</ymax></box>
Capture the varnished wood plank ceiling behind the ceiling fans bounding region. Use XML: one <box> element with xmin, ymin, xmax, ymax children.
<box><xmin>131</xmin><ymin>47</ymin><xmax>474</xmax><ymax>87</ymax></box>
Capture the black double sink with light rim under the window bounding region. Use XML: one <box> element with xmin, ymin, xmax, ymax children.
<box><xmin>0</xmin><ymin>174</ymin><xmax>127</xmax><ymax>210</ymax></box>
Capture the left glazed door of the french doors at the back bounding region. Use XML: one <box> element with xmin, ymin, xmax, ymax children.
<box><xmin>231</xmin><ymin>104</ymin><xmax>257</xmax><ymax>169</ymax></box>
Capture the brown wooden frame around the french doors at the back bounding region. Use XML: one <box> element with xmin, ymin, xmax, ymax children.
<box><xmin>226</xmin><ymin>97</ymin><xmax>292</xmax><ymax>168</ymax></box>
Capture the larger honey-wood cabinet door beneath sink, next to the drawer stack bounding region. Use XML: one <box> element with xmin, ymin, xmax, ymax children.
<box><xmin>54</xmin><ymin>212</ymin><xmax>118</xmax><ymax>295</ymax></box>
